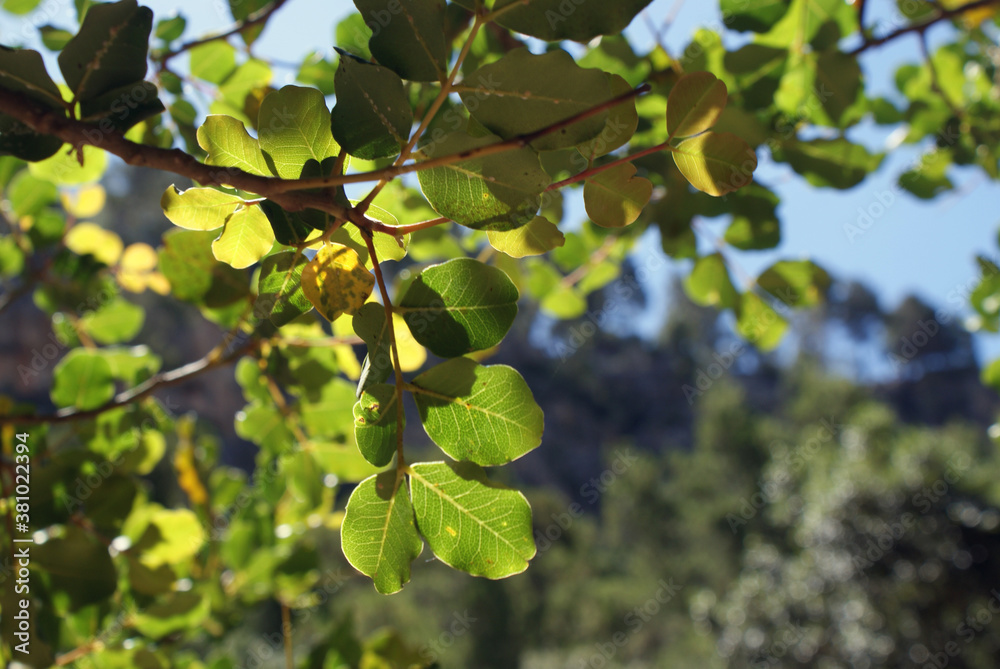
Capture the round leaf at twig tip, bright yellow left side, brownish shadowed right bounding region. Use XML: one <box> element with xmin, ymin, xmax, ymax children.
<box><xmin>673</xmin><ymin>132</ymin><xmax>757</xmax><ymax>197</ymax></box>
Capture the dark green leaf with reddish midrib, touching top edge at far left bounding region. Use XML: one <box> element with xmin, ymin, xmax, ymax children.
<box><xmin>59</xmin><ymin>0</ymin><xmax>153</xmax><ymax>102</ymax></box>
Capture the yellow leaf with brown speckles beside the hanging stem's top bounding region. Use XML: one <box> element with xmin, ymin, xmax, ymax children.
<box><xmin>302</xmin><ymin>244</ymin><xmax>375</xmax><ymax>321</ymax></box>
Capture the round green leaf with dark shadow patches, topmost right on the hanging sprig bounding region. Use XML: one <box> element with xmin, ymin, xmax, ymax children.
<box><xmin>395</xmin><ymin>258</ymin><xmax>519</xmax><ymax>358</ymax></box>
